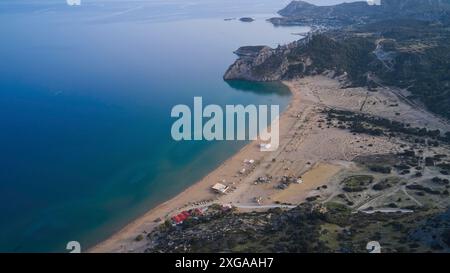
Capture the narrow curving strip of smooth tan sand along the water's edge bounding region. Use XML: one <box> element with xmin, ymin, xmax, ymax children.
<box><xmin>87</xmin><ymin>82</ymin><xmax>299</xmax><ymax>253</ymax></box>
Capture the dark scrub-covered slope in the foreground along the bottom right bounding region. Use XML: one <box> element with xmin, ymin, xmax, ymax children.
<box><xmin>145</xmin><ymin>203</ymin><xmax>450</xmax><ymax>253</ymax></box>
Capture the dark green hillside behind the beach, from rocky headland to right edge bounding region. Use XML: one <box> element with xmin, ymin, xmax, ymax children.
<box><xmin>224</xmin><ymin>19</ymin><xmax>450</xmax><ymax>117</ymax></box>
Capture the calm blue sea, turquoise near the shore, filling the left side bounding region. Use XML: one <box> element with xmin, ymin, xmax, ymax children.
<box><xmin>0</xmin><ymin>0</ymin><xmax>305</xmax><ymax>252</ymax></box>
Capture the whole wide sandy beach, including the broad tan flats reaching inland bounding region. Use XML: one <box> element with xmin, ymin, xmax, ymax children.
<box><xmin>89</xmin><ymin>76</ymin><xmax>448</xmax><ymax>252</ymax></box>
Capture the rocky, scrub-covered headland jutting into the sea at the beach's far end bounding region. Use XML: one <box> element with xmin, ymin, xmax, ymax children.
<box><xmin>224</xmin><ymin>34</ymin><xmax>377</xmax><ymax>84</ymax></box>
